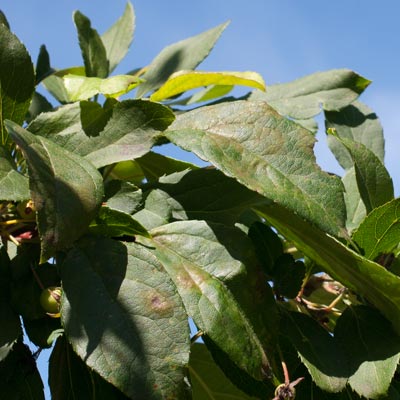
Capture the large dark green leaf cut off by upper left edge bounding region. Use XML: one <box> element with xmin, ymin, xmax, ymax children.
<box><xmin>0</xmin><ymin>23</ymin><xmax>35</xmax><ymax>136</ymax></box>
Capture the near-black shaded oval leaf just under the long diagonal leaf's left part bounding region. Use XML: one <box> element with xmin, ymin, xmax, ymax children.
<box><xmin>249</xmin><ymin>222</ymin><xmax>283</xmax><ymax>276</ymax></box>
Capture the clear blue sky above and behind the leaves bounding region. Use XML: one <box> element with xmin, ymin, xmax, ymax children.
<box><xmin>0</xmin><ymin>0</ymin><xmax>400</xmax><ymax>396</ymax></box>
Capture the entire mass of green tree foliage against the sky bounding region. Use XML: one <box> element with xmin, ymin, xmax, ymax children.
<box><xmin>0</xmin><ymin>3</ymin><xmax>400</xmax><ymax>400</ymax></box>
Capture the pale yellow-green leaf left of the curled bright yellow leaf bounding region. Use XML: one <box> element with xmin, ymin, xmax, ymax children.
<box><xmin>63</xmin><ymin>74</ymin><xmax>142</xmax><ymax>101</ymax></box>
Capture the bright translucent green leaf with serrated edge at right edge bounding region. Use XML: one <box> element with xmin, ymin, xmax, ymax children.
<box><xmin>353</xmin><ymin>199</ymin><xmax>400</xmax><ymax>260</ymax></box>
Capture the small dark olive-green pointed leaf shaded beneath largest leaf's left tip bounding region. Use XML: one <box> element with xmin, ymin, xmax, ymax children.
<box><xmin>135</xmin><ymin>151</ymin><xmax>199</xmax><ymax>181</ymax></box>
